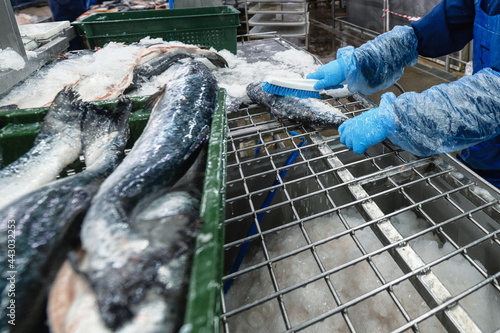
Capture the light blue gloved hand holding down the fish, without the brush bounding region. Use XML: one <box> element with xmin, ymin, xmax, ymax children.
<box><xmin>339</xmin><ymin>104</ymin><xmax>396</xmax><ymax>154</ymax></box>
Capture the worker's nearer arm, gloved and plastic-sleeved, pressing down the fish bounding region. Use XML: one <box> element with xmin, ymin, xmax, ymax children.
<box><xmin>339</xmin><ymin>68</ymin><xmax>500</xmax><ymax>156</ymax></box>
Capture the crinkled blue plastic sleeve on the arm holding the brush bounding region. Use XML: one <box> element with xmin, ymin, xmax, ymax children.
<box><xmin>337</xmin><ymin>26</ymin><xmax>418</xmax><ymax>95</ymax></box>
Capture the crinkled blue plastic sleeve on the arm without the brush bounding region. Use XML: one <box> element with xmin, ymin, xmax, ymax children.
<box><xmin>381</xmin><ymin>68</ymin><xmax>500</xmax><ymax>156</ymax></box>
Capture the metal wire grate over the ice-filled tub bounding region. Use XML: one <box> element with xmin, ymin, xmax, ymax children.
<box><xmin>221</xmin><ymin>94</ymin><xmax>500</xmax><ymax>332</ymax></box>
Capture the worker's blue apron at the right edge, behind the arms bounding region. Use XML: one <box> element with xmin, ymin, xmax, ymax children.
<box><xmin>458</xmin><ymin>0</ymin><xmax>500</xmax><ymax>187</ymax></box>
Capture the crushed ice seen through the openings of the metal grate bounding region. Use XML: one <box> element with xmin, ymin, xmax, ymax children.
<box><xmin>225</xmin><ymin>208</ymin><xmax>500</xmax><ymax>332</ymax></box>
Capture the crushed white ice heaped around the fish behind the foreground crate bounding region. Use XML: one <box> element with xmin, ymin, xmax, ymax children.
<box><xmin>0</xmin><ymin>37</ymin><xmax>319</xmax><ymax>109</ymax></box>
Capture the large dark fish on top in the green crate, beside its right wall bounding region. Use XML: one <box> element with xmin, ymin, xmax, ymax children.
<box><xmin>79</xmin><ymin>61</ymin><xmax>217</xmax><ymax>329</ymax></box>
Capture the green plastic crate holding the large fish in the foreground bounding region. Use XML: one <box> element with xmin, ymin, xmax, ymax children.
<box><xmin>0</xmin><ymin>89</ymin><xmax>227</xmax><ymax>332</ymax></box>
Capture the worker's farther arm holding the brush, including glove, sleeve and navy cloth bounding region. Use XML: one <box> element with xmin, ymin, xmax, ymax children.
<box><xmin>308</xmin><ymin>0</ymin><xmax>480</xmax><ymax>94</ymax></box>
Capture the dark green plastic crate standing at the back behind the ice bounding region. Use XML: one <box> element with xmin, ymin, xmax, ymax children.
<box><xmin>72</xmin><ymin>6</ymin><xmax>240</xmax><ymax>54</ymax></box>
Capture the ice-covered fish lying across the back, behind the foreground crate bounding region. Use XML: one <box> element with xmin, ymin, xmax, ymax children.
<box><xmin>0</xmin><ymin>40</ymin><xmax>227</xmax><ymax>109</ymax></box>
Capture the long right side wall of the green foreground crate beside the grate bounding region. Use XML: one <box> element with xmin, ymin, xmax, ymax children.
<box><xmin>184</xmin><ymin>89</ymin><xmax>228</xmax><ymax>333</ymax></box>
